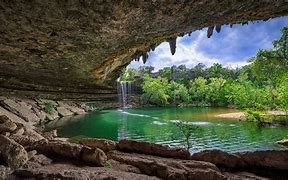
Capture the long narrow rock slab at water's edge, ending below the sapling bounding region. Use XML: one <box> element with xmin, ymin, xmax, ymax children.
<box><xmin>118</xmin><ymin>140</ymin><xmax>190</xmax><ymax>159</ymax></box>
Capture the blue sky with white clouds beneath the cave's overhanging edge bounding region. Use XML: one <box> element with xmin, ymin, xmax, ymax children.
<box><xmin>129</xmin><ymin>17</ymin><xmax>288</xmax><ymax>70</ymax></box>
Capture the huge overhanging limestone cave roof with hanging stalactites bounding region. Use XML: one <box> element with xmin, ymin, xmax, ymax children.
<box><xmin>0</xmin><ymin>0</ymin><xmax>288</xmax><ymax>99</ymax></box>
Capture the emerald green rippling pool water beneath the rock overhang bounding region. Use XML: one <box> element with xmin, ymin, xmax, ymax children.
<box><xmin>46</xmin><ymin>108</ymin><xmax>288</xmax><ymax>153</ymax></box>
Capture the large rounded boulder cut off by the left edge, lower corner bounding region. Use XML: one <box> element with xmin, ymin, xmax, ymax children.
<box><xmin>0</xmin><ymin>135</ymin><xmax>28</xmax><ymax>169</ymax></box>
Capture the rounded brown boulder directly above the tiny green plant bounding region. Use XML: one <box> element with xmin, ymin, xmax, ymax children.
<box><xmin>81</xmin><ymin>147</ymin><xmax>107</xmax><ymax>166</ymax></box>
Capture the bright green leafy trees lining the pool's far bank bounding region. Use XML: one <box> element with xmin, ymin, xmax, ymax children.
<box><xmin>121</xmin><ymin>27</ymin><xmax>288</xmax><ymax>111</ymax></box>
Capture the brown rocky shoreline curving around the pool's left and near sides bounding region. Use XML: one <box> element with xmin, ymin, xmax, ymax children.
<box><xmin>0</xmin><ymin>97</ymin><xmax>288</xmax><ymax>180</ymax></box>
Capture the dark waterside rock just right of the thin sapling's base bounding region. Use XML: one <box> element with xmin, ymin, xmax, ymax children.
<box><xmin>190</xmin><ymin>150</ymin><xmax>244</xmax><ymax>168</ymax></box>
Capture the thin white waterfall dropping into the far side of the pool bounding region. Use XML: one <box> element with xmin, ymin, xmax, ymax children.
<box><xmin>119</xmin><ymin>81</ymin><xmax>132</xmax><ymax>108</ymax></box>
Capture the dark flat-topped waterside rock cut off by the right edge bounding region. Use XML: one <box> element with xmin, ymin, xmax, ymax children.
<box><xmin>236</xmin><ymin>151</ymin><xmax>288</xmax><ymax>170</ymax></box>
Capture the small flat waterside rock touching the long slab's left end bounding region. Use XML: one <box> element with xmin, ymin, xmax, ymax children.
<box><xmin>79</xmin><ymin>138</ymin><xmax>117</xmax><ymax>152</ymax></box>
